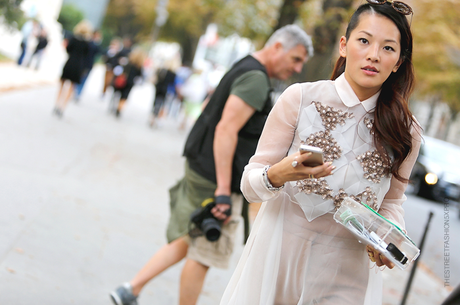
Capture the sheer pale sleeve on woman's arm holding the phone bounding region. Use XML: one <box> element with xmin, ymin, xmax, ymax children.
<box><xmin>241</xmin><ymin>84</ymin><xmax>302</xmax><ymax>202</ymax></box>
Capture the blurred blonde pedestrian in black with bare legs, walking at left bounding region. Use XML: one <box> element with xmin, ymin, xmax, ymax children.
<box><xmin>53</xmin><ymin>20</ymin><xmax>93</xmax><ymax>117</ymax></box>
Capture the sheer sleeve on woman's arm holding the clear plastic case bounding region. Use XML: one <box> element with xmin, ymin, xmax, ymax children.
<box><xmin>379</xmin><ymin>124</ymin><xmax>422</xmax><ymax>229</ymax></box>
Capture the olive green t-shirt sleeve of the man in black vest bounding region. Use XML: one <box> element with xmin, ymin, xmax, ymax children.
<box><xmin>230</xmin><ymin>70</ymin><xmax>270</xmax><ymax>111</ymax></box>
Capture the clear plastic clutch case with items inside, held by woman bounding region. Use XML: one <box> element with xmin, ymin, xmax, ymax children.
<box><xmin>334</xmin><ymin>197</ymin><xmax>420</xmax><ymax>270</ymax></box>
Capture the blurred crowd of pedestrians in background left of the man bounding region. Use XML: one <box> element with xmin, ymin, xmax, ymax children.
<box><xmin>22</xmin><ymin>20</ymin><xmax>222</xmax><ymax>129</ymax></box>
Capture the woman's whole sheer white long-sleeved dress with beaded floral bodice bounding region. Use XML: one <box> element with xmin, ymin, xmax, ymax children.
<box><xmin>221</xmin><ymin>75</ymin><xmax>421</xmax><ymax>305</ymax></box>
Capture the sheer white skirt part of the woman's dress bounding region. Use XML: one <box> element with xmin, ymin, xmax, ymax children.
<box><xmin>221</xmin><ymin>194</ymin><xmax>382</xmax><ymax>305</ymax></box>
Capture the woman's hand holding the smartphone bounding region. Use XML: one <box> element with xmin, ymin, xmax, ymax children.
<box><xmin>267</xmin><ymin>152</ymin><xmax>335</xmax><ymax>187</ymax></box>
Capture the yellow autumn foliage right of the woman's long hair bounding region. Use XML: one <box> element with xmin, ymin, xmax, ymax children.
<box><xmin>412</xmin><ymin>0</ymin><xmax>460</xmax><ymax>112</ymax></box>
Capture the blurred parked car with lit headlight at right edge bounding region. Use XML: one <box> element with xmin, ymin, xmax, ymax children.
<box><xmin>410</xmin><ymin>136</ymin><xmax>460</xmax><ymax>202</ymax></box>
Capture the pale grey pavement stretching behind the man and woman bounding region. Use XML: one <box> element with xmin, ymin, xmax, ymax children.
<box><xmin>0</xmin><ymin>66</ymin><xmax>452</xmax><ymax>305</ymax></box>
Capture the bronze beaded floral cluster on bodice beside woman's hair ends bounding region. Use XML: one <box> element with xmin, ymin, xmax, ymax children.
<box><xmin>357</xmin><ymin>150</ymin><xmax>390</xmax><ymax>183</ymax></box>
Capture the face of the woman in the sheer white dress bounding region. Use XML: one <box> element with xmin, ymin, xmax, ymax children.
<box><xmin>340</xmin><ymin>13</ymin><xmax>401</xmax><ymax>101</ymax></box>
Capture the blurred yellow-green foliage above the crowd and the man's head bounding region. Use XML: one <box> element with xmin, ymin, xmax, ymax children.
<box><xmin>104</xmin><ymin>0</ymin><xmax>282</xmax><ymax>47</ymax></box>
